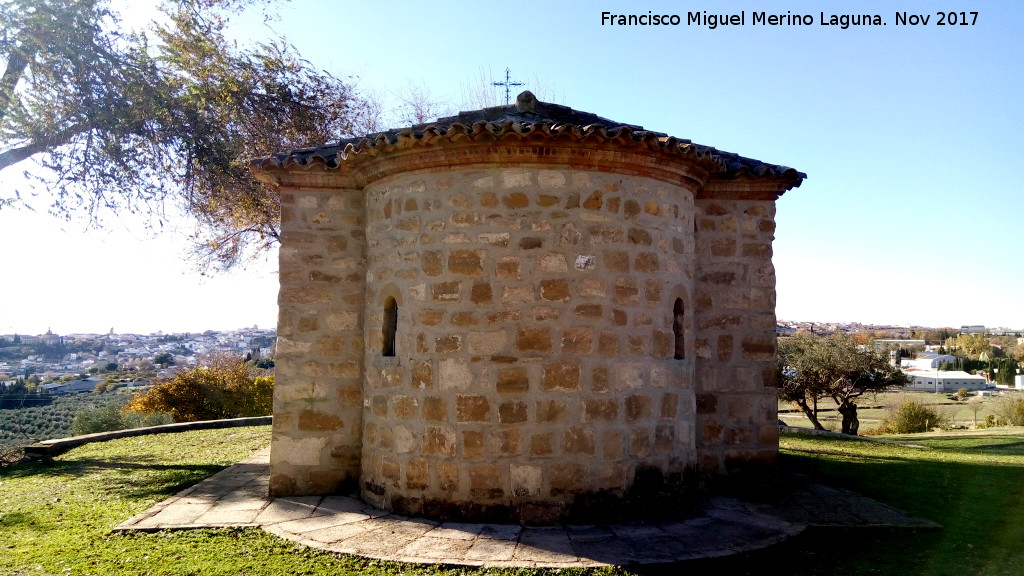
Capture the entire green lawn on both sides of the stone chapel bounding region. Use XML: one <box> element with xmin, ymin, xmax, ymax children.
<box><xmin>6</xmin><ymin>426</ymin><xmax>1024</xmax><ymax>576</ymax></box>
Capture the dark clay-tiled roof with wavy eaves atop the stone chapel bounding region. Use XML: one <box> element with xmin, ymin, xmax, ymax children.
<box><xmin>251</xmin><ymin>91</ymin><xmax>807</xmax><ymax>186</ymax></box>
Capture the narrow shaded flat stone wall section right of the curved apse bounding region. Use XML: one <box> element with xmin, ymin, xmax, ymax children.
<box><xmin>694</xmin><ymin>198</ymin><xmax>778</xmax><ymax>475</ymax></box>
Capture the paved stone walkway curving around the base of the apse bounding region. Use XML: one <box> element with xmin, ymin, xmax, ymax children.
<box><xmin>115</xmin><ymin>449</ymin><xmax>937</xmax><ymax>568</ymax></box>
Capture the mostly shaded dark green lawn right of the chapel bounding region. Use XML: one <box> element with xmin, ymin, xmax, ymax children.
<box><xmin>765</xmin><ymin>435</ymin><xmax>1024</xmax><ymax>576</ymax></box>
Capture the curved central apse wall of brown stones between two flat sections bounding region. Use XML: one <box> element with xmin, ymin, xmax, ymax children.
<box><xmin>356</xmin><ymin>168</ymin><xmax>700</xmax><ymax>522</ymax></box>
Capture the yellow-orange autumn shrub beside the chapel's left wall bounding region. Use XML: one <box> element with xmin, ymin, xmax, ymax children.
<box><xmin>125</xmin><ymin>358</ymin><xmax>273</xmax><ymax>422</ymax></box>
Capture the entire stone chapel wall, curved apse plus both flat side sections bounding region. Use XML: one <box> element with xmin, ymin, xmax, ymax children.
<box><xmin>258</xmin><ymin>108</ymin><xmax>793</xmax><ymax>523</ymax></box>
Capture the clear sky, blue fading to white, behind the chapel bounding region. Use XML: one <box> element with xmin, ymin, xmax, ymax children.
<box><xmin>0</xmin><ymin>0</ymin><xmax>1024</xmax><ymax>333</ymax></box>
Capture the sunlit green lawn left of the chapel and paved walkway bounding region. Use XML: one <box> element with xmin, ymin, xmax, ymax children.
<box><xmin>0</xmin><ymin>426</ymin><xmax>613</xmax><ymax>576</ymax></box>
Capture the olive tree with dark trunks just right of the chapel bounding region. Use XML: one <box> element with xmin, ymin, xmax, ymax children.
<box><xmin>778</xmin><ymin>334</ymin><xmax>907</xmax><ymax>435</ymax></box>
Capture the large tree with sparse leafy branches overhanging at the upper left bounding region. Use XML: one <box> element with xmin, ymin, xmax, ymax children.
<box><xmin>0</xmin><ymin>0</ymin><xmax>377</xmax><ymax>266</ymax></box>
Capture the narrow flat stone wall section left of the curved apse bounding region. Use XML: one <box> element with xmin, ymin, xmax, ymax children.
<box><xmin>270</xmin><ymin>188</ymin><xmax>366</xmax><ymax>496</ymax></box>
